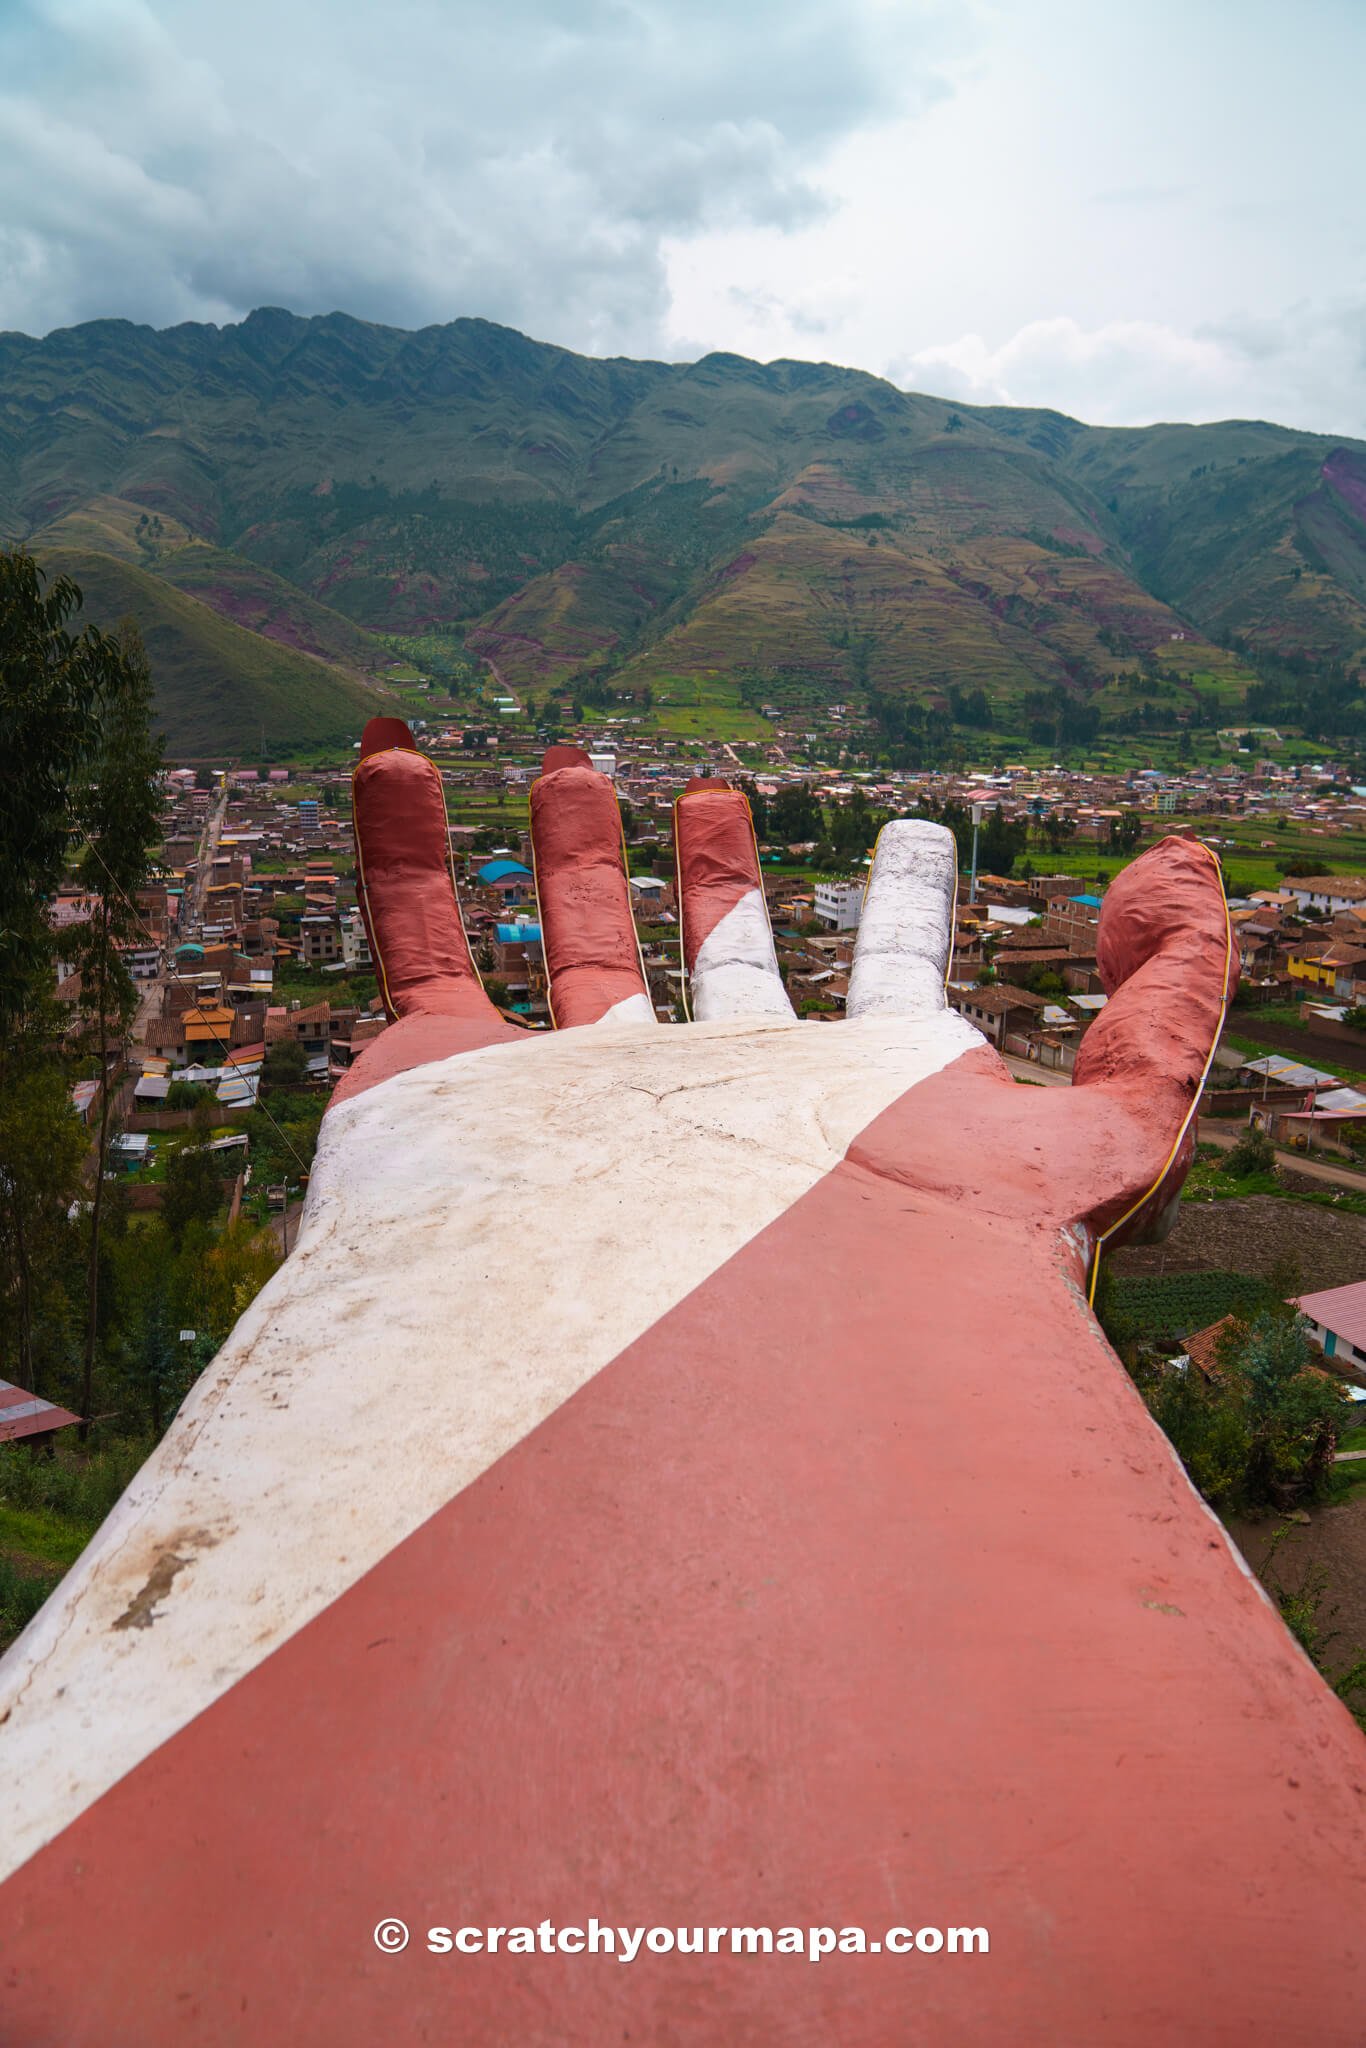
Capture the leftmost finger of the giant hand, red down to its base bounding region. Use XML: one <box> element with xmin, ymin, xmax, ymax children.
<box><xmin>352</xmin><ymin>719</ymin><xmax>510</xmax><ymax>1036</ymax></box>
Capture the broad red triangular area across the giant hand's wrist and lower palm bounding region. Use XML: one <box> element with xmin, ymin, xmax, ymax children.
<box><xmin>2</xmin><ymin>1114</ymin><xmax>1366</xmax><ymax>2048</ymax></box>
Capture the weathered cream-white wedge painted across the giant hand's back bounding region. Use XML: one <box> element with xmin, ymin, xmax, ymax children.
<box><xmin>0</xmin><ymin>1012</ymin><xmax>983</xmax><ymax>1876</ymax></box>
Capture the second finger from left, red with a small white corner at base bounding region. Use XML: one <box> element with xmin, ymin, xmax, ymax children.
<box><xmin>530</xmin><ymin>748</ymin><xmax>655</xmax><ymax>1030</ymax></box>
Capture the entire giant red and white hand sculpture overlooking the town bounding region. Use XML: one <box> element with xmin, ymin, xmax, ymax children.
<box><xmin>0</xmin><ymin>721</ymin><xmax>1366</xmax><ymax>2048</ymax></box>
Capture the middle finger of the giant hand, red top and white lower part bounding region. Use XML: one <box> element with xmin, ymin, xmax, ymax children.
<box><xmin>674</xmin><ymin>780</ymin><xmax>793</xmax><ymax>1022</ymax></box>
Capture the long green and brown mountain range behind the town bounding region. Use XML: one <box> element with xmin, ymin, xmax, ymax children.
<box><xmin>0</xmin><ymin>309</ymin><xmax>1366</xmax><ymax>743</ymax></box>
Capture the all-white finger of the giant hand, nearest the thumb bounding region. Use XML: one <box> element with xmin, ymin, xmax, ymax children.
<box><xmin>846</xmin><ymin>817</ymin><xmax>958</xmax><ymax>1018</ymax></box>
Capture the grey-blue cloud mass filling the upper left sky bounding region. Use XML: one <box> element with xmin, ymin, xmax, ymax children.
<box><xmin>0</xmin><ymin>0</ymin><xmax>946</xmax><ymax>350</ymax></box>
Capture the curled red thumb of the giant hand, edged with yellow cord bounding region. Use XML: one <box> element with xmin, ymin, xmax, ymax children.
<box><xmin>1073</xmin><ymin>838</ymin><xmax>1239</xmax><ymax>1241</ymax></box>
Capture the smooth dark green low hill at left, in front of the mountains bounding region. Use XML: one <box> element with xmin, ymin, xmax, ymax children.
<box><xmin>41</xmin><ymin>549</ymin><xmax>387</xmax><ymax>760</ymax></box>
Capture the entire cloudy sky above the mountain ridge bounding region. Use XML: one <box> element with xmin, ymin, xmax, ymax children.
<box><xmin>0</xmin><ymin>0</ymin><xmax>1366</xmax><ymax>434</ymax></box>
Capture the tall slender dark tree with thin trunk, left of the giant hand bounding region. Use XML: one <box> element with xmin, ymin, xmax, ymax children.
<box><xmin>74</xmin><ymin>621</ymin><xmax>162</xmax><ymax>1438</ymax></box>
